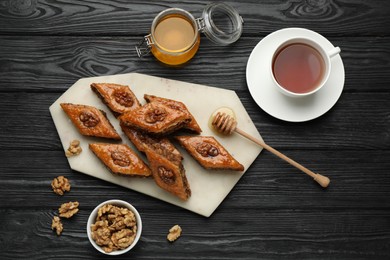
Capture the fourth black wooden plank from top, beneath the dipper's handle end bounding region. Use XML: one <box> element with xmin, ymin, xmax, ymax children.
<box><xmin>0</xmin><ymin>150</ymin><xmax>390</xmax><ymax>210</ymax></box>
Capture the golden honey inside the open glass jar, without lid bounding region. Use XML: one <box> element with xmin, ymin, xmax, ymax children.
<box><xmin>151</xmin><ymin>14</ymin><xmax>200</xmax><ymax>65</ymax></box>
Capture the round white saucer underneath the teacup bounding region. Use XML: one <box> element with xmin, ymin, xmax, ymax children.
<box><xmin>246</xmin><ymin>28</ymin><xmax>344</xmax><ymax>122</ymax></box>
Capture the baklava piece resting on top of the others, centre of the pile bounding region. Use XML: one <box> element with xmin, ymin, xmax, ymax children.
<box><xmin>119</xmin><ymin>103</ymin><xmax>191</xmax><ymax>135</ymax></box>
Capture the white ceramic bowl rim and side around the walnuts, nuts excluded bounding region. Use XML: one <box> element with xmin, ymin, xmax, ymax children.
<box><xmin>87</xmin><ymin>200</ymin><xmax>142</xmax><ymax>255</ymax></box>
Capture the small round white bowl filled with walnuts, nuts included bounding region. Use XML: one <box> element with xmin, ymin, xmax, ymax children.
<box><xmin>87</xmin><ymin>200</ymin><xmax>142</xmax><ymax>255</ymax></box>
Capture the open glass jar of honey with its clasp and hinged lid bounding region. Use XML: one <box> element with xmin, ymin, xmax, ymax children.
<box><xmin>136</xmin><ymin>3</ymin><xmax>243</xmax><ymax>66</ymax></box>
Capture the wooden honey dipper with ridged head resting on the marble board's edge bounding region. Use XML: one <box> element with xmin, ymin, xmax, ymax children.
<box><xmin>211</xmin><ymin>109</ymin><xmax>330</xmax><ymax>188</ymax></box>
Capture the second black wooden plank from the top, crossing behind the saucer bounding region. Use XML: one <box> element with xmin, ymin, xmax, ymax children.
<box><xmin>0</xmin><ymin>36</ymin><xmax>390</xmax><ymax>93</ymax></box>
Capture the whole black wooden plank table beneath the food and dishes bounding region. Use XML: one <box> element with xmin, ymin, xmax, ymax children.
<box><xmin>0</xmin><ymin>0</ymin><xmax>390</xmax><ymax>259</ymax></box>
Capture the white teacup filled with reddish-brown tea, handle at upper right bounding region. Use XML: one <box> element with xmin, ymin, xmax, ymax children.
<box><xmin>270</xmin><ymin>37</ymin><xmax>340</xmax><ymax>97</ymax></box>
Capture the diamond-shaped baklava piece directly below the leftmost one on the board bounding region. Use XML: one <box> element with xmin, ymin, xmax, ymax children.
<box><xmin>89</xmin><ymin>143</ymin><xmax>151</xmax><ymax>177</ymax></box>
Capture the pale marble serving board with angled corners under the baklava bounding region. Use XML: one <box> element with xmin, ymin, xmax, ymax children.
<box><xmin>50</xmin><ymin>73</ymin><xmax>262</xmax><ymax>217</ymax></box>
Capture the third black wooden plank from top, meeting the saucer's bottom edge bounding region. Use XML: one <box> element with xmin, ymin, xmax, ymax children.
<box><xmin>0</xmin><ymin>91</ymin><xmax>390</xmax><ymax>150</ymax></box>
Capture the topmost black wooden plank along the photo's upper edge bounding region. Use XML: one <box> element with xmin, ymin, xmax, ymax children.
<box><xmin>0</xmin><ymin>0</ymin><xmax>390</xmax><ymax>36</ymax></box>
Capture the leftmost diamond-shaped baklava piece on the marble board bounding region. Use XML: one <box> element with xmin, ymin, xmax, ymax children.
<box><xmin>60</xmin><ymin>103</ymin><xmax>121</xmax><ymax>140</ymax></box>
